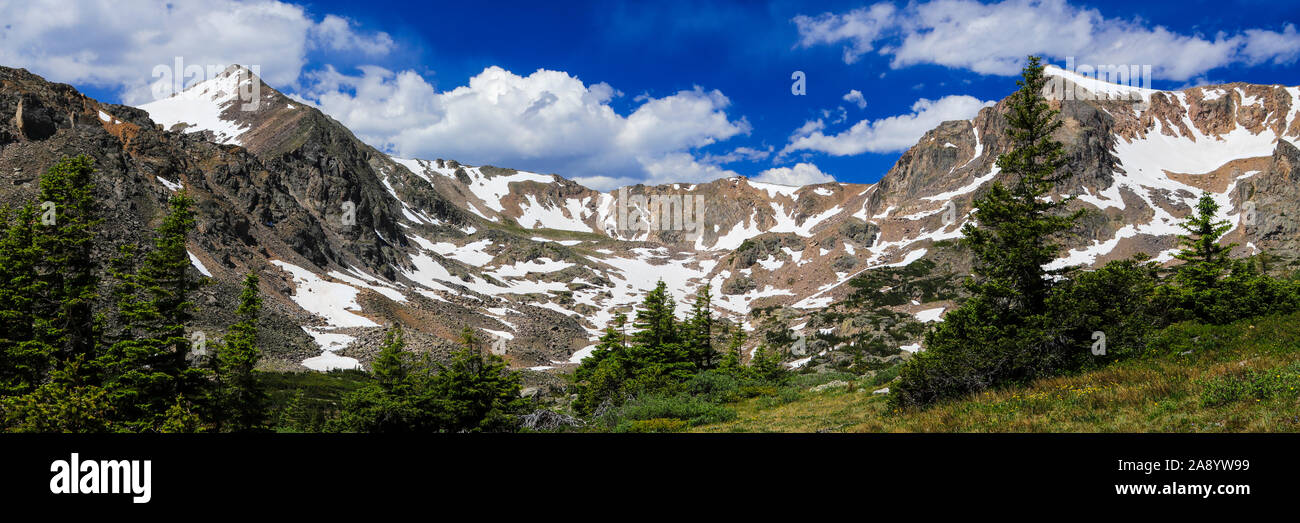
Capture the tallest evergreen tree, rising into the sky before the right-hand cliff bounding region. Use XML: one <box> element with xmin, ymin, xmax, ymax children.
<box><xmin>889</xmin><ymin>56</ymin><xmax>1087</xmax><ymax>407</ymax></box>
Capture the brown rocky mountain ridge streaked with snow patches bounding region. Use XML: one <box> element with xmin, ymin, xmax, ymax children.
<box><xmin>0</xmin><ymin>68</ymin><xmax>1300</xmax><ymax>371</ymax></box>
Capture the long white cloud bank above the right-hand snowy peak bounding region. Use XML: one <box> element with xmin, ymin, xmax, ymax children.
<box><xmin>793</xmin><ymin>0</ymin><xmax>1300</xmax><ymax>81</ymax></box>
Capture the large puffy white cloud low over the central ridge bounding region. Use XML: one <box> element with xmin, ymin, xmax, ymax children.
<box><xmin>303</xmin><ymin>66</ymin><xmax>750</xmax><ymax>189</ymax></box>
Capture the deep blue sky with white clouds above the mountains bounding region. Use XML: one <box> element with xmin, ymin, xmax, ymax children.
<box><xmin>0</xmin><ymin>0</ymin><xmax>1300</xmax><ymax>189</ymax></box>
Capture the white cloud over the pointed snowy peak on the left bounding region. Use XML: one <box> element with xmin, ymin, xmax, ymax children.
<box><xmin>0</xmin><ymin>0</ymin><xmax>393</xmax><ymax>104</ymax></box>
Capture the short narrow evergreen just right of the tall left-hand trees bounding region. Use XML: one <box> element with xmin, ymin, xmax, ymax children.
<box><xmin>217</xmin><ymin>272</ymin><xmax>269</xmax><ymax>432</ymax></box>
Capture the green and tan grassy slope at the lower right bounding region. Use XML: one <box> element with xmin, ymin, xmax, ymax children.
<box><xmin>690</xmin><ymin>314</ymin><xmax>1300</xmax><ymax>432</ymax></box>
